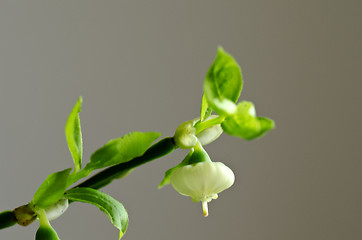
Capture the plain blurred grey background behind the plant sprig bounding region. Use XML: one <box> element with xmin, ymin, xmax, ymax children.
<box><xmin>0</xmin><ymin>0</ymin><xmax>362</xmax><ymax>240</ymax></box>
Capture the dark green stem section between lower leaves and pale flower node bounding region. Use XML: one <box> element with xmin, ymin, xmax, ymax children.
<box><xmin>75</xmin><ymin>137</ymin><xmax>177</xmax><ymax>189</ymax></box>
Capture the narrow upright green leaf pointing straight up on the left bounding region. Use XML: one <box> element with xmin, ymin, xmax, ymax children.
<box><xmin>65</xmin><ymin>97</ymin><xmax>83</xmax><ymax>172</ymax></box>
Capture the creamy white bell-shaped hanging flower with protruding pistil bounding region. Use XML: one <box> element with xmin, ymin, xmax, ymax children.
<box><xmin>171</xmin><ymin>161</ymin><xmax>235</xmax><ymax>217</ymax></box>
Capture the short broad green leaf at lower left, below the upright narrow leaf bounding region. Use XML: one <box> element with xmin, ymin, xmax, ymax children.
<box><xmin>33</xmin><ymin>168</ymin><xmax>72</xmax><ymax>208</ymax></box>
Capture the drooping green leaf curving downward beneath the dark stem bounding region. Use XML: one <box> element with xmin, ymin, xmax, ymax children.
<box><xmin>64</xmin><ymin>188</ymin><xmax>128</xmax><ymax>238</ymax></box>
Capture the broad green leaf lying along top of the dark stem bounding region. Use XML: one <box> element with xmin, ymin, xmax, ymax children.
<box><xmin>85</xmin><ymin>132</ymin><xmax>161</xmax><ymax>170</ymax></box>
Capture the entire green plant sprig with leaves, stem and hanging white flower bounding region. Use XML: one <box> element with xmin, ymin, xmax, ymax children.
<box><xmin>0</xmin><ymin>47</ymin><xmax>274</xmax><ymax>240</ymax></box>
